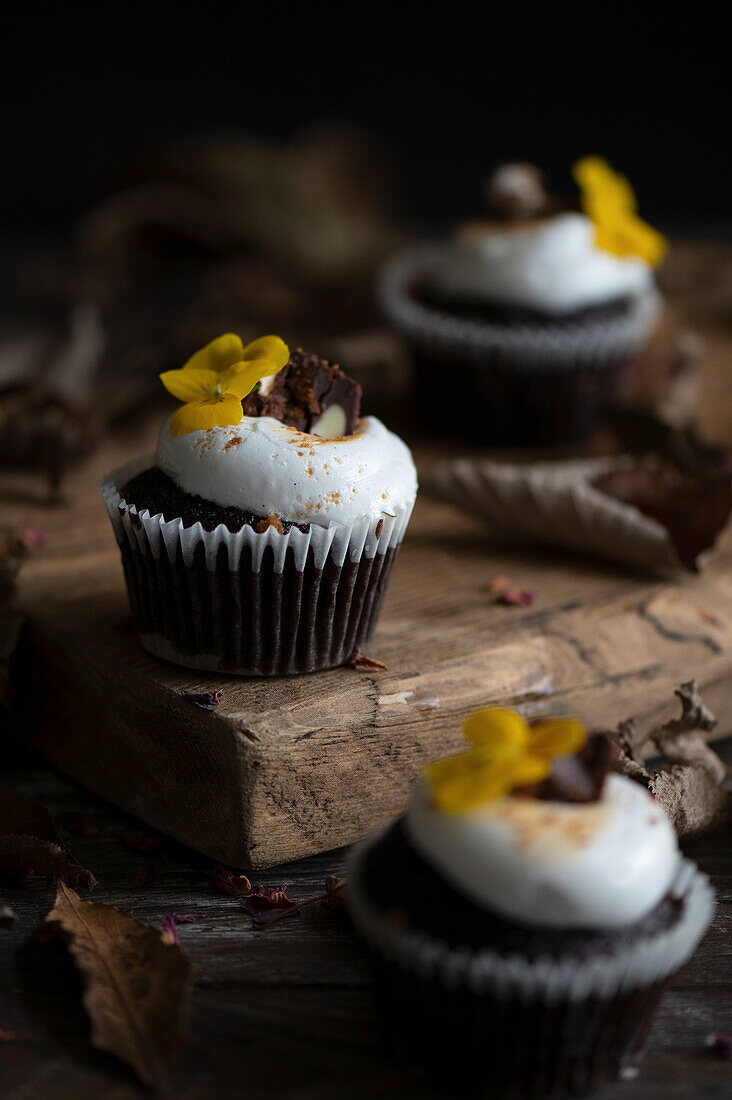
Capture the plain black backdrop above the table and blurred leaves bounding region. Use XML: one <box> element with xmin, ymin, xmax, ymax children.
<box><xmin>0</xmin><ymin>2</ymin><xmax>730</xmax><ymax>232</ymax></box>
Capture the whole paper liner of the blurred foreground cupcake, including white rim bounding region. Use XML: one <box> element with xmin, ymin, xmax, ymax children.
<box><xmin>347</xmin><ymin>836</ymin><xmax>714</xmax><ymax>1097</ymax></box>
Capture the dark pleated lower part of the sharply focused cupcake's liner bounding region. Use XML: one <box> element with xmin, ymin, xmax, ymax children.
<box><xmin>121</xmin><ymin>541</ymin><xmax>398</xmax><ymax>677</ymax></box>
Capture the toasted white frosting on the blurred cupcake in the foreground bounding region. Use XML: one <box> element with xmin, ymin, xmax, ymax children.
<box><xmin>404</xmin><ymin>774</ymin><xmax>680</xmax><ymax>930</ymax></box>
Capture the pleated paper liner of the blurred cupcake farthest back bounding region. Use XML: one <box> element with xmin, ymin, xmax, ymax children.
<box><xmin>379</xmin><ymin>243</ymin><xmax>663</xmax><ymax>444</ymax></box>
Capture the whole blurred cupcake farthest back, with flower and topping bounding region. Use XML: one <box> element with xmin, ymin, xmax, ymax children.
<box><xmin>379</xmin><ymin>157</ymin><xmax>666</xmax><ymax>446</ymax></box>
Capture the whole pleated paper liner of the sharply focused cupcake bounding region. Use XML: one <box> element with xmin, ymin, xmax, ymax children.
<box><xmin>102</xmin><ymin>457</ymin><xmax>412</xmax><ymax>675</ymax></box>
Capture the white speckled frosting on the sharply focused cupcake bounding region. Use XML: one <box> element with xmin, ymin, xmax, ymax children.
<box><xmin>155</xmin><ymin>417</ymin><xmax>417</xmax><ymax>527</ymax></box>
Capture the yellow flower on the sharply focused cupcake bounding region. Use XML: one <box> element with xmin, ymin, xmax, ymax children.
<box><xmin>160</xmin><ymin>332</ymin><xmax>289</xmax><ymax>436</ymax></box>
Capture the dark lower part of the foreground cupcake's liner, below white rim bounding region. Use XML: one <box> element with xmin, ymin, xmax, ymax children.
<box><xmin>375</xmin><ymin>959</ymin><xmax>666</xmax><ymax>1100</ymax></box>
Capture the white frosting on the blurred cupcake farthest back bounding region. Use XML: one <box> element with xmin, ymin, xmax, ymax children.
<box><xmin>433</xmin><ymin>212</ymin><xmax>654</xmax><ymax>315</ymax></box>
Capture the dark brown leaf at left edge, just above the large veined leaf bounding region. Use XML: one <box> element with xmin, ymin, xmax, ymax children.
<box><xmin>0</xmin><ymin>791</ymin><xmax>97</xmax><ymax>890</ymax></box>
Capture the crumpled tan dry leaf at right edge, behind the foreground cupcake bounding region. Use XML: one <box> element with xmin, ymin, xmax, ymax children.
<box><xmin>616</xmin><ymin>680</ymin><xmax>732</xmax><ymax>836</ymax></box>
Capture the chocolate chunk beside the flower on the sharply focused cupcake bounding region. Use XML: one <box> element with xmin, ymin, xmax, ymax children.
<box><xmin>243</xmin><ymin>348</ymin><xmax>361</xmax><ymax>438</ymax></box>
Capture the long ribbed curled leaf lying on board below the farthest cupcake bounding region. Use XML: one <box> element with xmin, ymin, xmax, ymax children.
<box><xmin>423</xmin><ymin>458</ymin><xmax>732</xmax><ymax>571</ymax></box>
